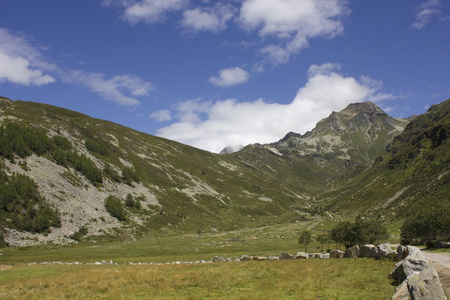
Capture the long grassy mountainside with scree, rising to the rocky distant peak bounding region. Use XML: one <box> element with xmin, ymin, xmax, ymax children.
<box><xmin>0</xmin><ymin>98</ymin><xmax>407</xmax><ymax>246</ymax></box>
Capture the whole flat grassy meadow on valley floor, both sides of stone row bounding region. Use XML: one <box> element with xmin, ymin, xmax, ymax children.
<box><xmin>0</xmin><ymin>224</ymin><xmax>400</xmax><ymax>299</ymax></box>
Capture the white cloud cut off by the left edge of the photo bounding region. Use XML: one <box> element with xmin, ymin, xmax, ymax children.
<box><xmin>0</xmin><ymin>28</ymin><xmax>55</xmax><ymax>86</ymax></box>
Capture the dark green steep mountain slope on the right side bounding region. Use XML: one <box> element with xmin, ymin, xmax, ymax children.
<box><xmin>318</xmin><ymin>99</ymin><xmax>450</xmax><ymax>219</ymax></box>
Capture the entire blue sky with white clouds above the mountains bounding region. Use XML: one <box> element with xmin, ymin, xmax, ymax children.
<box><xmin>0</xmin><ymin>0</ymin><xmax>450</xmax><ymax>153</ymax></box>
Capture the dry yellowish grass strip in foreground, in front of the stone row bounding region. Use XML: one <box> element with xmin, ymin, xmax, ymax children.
<box><xmin>0</xmin><ymin>259</ymin><xmax>393</xmax><ymax>299</ymax></box>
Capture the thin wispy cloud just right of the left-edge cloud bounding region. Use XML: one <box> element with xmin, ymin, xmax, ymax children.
<box><xmin>61</xmin><ymin>70</ymin><xmax>153</xmax><ymax>106</ymax></box>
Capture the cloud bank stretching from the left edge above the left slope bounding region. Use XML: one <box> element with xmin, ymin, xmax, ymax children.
<box><xmin>0</xmin><ymin>28</ymin><xmax>153</xmax><ymax>106</ymax></box>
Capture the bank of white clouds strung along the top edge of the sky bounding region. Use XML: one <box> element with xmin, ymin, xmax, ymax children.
<box><xmin>103</xmin><ymin>0</ymin><xmax>350</xmax><ymax>66</ymax></box>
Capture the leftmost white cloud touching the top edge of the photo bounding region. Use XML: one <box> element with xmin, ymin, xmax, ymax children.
<box><xmin>103</xmin><ymin>0</ymin><xmax>189</xmax><ymax>24</ymax></box>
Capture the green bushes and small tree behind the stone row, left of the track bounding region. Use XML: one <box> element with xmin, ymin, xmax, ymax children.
<box><xmin>298</xmin><ymin>217</ymin><xmax>389</xmax><ymax>252</ymax></box>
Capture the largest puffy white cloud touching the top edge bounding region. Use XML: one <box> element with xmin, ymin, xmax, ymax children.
<box><xmin>240</xmin><ymin>0</ymin><xmax>349</xmax><ymax>65</ymax></box>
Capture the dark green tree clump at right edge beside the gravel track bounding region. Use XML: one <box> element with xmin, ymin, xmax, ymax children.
<box><xmin>400</xmin><ymin>201</ymin><xmax>450</xmax><ymax>246</ymax></box>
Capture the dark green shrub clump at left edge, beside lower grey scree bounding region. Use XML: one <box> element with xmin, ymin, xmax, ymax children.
<box><xmin>0</xmin><ymin>169</ymin><xmax>61</xmax><ymax>233</ymax></box>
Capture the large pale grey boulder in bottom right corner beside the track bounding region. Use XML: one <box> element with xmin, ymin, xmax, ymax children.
<box><xmin>389</xmin><ymin>246</ymin><xmax>447</xmax><ymax>300</ymax></box>
